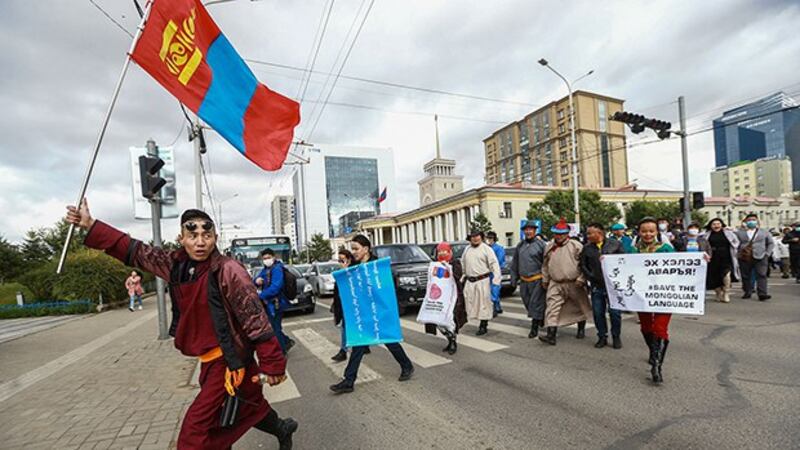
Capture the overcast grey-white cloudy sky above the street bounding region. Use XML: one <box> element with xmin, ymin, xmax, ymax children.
<box><xmin>0</xmin><ymin>0</ymin><xmax>800</xmax><ymax>241</ymax></box>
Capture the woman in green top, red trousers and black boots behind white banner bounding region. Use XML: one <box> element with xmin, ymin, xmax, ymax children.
<box><xmin>633</xmin><ymin>217</ymin><xmax>675</xmax><ymax>383</ymax></box>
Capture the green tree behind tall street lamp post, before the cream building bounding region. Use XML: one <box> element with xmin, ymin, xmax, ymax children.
<box><xmin>527</xmin><ymin>191</ymin><xmax>621</xmax><ymax>236</ymax></box>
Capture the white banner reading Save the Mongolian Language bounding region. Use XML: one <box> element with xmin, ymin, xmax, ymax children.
<box><xmin>602</xmin><ymin>253</ymin><xmax>707</xmax><ymax>316</ymax></box>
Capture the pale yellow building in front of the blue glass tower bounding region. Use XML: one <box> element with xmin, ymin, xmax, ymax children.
<box><xmin>711</xmin><ymin>157</ymin><xmax>792</xmax><ymax>197</ymax></box>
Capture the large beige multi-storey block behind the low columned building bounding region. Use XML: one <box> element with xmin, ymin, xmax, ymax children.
<box><xmin>483</xmin><ymin>91</ymin><xmax>628</xmax><ymax>189</ymax></box>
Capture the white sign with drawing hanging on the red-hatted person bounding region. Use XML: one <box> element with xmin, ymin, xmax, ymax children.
<box><xmin>417</xmin><ymin>262</ymin><xmax>458</xmax><ymax>331</ymax></box>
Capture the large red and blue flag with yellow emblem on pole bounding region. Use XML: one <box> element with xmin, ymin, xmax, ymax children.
<box><xmin>131</xmin><ymin>0</ymin><xmax>300</xmax><ymax>170</ymax></box>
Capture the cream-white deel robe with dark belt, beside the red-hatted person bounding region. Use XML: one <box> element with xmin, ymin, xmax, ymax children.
<box><xmin>461</xmin><ymin>243</ymin><xmax>502</xmax><ymax>320</ymax></box>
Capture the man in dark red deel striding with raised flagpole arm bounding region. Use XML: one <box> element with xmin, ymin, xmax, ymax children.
<box><xmin>67</xmin><ymin>200</ymin><xmax>297</xmax><ymax>450</ymax></box>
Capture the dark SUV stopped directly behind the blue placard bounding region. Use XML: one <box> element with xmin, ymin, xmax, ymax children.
<box><xmin>373</xmin><ymin>244</ymin><xmax>431</xmax><ymax>315</ymax></box>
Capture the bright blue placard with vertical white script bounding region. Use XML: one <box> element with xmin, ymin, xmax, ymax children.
<box><xmin>333</xmin><ymin>258</ymin><xmax>403</xmax><ymax>347</ymax></box>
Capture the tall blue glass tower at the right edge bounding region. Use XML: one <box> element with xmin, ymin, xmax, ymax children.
<box><xmin>713</xmin><ymin>92</ymin><xmax>800</xmax><ymax>190</ymax></box>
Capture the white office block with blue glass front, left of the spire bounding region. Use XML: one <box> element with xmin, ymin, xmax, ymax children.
<box><xmin>292</xmin><ymin>145</ymin><xmax>397</xmax><ymax>241</ymax></box>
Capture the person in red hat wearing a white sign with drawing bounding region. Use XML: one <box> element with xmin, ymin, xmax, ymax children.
<box><xmin>417</xmin><ymin>242</ymin><xmax>467</xmax><ymax>355</ymax></box>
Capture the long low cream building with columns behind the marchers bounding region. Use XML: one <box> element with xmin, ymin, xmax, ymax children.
<box><xmin>359</xmin><ymin>183</ymin><xmax>683</xmax><ymax>246</ymax></box>
